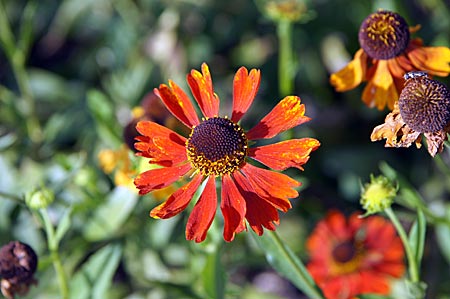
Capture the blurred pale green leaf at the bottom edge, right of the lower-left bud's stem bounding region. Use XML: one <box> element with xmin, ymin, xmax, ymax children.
<box><xmin>70</xmin><ymin>244</ymin><xmax>122</xmax><ymax>299</ymax></box>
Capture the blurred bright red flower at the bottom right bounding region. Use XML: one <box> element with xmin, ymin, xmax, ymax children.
<box><xmin>306</xmin><ymin>211</ymin><xmax>405</xmax><ymax>299</ymax></box>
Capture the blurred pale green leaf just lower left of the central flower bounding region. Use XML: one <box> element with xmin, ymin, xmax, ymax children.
<box><xmin>83</xmin><ymin>186</ymin><xmax>138</xmax><ymax>241</ymax></box>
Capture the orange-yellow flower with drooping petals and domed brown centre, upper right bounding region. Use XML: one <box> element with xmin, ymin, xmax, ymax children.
<box><xmin>330</xmin><ymin>10</ymin><xmax>450</xmax><ymax>110</ymax></box>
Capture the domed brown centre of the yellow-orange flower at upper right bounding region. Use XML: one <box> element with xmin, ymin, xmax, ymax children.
<box><xmin>358</xmin><ymin>10</ymin><xmax>410</xmax><ymax>59</ymax></box>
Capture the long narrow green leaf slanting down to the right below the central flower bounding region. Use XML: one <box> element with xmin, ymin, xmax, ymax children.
<box><xmin>253</xmin><ymin>231</ymin><xmax>324</xmax><ymax>299</ymax></box>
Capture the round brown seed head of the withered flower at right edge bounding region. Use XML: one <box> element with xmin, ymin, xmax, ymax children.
<box><xmin>398</xmin><ymin>76</ymin><xmax>450</xmax><ymax>133</ymax></box>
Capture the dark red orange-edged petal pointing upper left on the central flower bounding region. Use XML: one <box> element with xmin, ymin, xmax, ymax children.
<box><xmin>154</xmin><ymin>80</ymin><xmax>200</xmax><ymax>128</ymax></box>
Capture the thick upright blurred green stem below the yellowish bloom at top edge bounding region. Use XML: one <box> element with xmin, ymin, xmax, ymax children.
<box><xmin>277</xmin><ymin>20</ymin><xmax>295</xmax><ymax>97</ymax></box>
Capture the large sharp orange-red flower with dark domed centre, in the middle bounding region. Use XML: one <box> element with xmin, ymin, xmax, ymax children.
<box><xmin>134</xmin><ymin>64</ymin><xmax>320</xmax><ymax>242</ymax></box>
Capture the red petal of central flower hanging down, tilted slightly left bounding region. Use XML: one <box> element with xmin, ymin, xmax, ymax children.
<box><xmin>186</xmin><ymin>176</ymin><xmax>217</xmax><ymax>243</ymax></box>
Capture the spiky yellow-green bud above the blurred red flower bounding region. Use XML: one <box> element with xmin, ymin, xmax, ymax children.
<box><xmin>360</xmin><ymin>175</ymin><xmax>397</xmax><ymax>216</ymax></box>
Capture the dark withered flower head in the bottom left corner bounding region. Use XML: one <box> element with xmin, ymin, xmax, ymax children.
<box><xmin>0</xmin><ymin>241</ymin><xmax>38</xmax><ymax>299</ymax></box>
